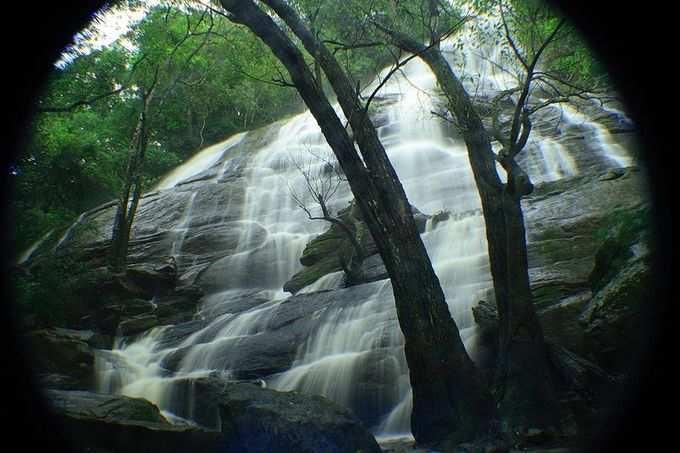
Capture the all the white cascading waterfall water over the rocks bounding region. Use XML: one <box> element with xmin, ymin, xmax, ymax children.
<box><xmin>89</xmin><ymin>12</ymin><xmax>630</xmax><ymax>436</ymax></box>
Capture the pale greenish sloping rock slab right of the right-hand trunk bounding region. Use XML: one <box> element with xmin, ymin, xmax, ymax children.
<box><xmin>523</xmin><ymin>168</ymin><xmax>649</xmax><ymax>308</ymax></box>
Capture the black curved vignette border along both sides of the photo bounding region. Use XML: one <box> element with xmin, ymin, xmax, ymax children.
<box><xmin>0</xmin><ymin>0</ymin><xmax>678</xmax><ymax>452</ymax></box>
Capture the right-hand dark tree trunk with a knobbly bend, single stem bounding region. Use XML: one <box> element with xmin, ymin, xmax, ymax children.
<box><xmin>383</xmin><ymin>29</ymin><xmax>559</xmax><ymax>432</ymax></box>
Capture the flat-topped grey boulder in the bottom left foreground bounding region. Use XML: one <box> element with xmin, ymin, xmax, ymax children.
<box><xmin>47</xmin><ymin>390</ymin><xmax>224</xmax><ymax>453</ymax></box>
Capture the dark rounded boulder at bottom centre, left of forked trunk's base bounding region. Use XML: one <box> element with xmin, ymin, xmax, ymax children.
<box><xmin>162</xmin><ymin>378</ymin><xmax>381</xmax><ymax>453</ymax></box>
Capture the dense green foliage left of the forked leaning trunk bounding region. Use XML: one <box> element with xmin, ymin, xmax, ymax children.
<box><xmin>10</xmin><ymin>2</ymin><xmax>301</xmax><ymax>258</ymax></box>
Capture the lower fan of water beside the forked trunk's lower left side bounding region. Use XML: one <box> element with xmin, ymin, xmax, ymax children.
<box><xmin>269</xmin><ymin>280</ymin><xmax>405</xmax><ymax>418</ymax></box>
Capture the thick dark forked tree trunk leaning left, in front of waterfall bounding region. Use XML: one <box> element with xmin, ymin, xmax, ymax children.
<box><xmin>221</xmin><ymin>0</ymin><xmax>494</xmax><ymax>442</ymax></box>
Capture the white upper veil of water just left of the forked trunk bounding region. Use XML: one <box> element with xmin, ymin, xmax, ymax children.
<box><xmin>195</xmin><ymin>113</ymin><xmax>346</xmax><ymax>298</ymax></box>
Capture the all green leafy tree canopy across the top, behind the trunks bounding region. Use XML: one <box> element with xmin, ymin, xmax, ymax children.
<box><xmin>8</xmin><ymin>0</ymin><xmax>603</xmax><ymax>262</ymax></box>
